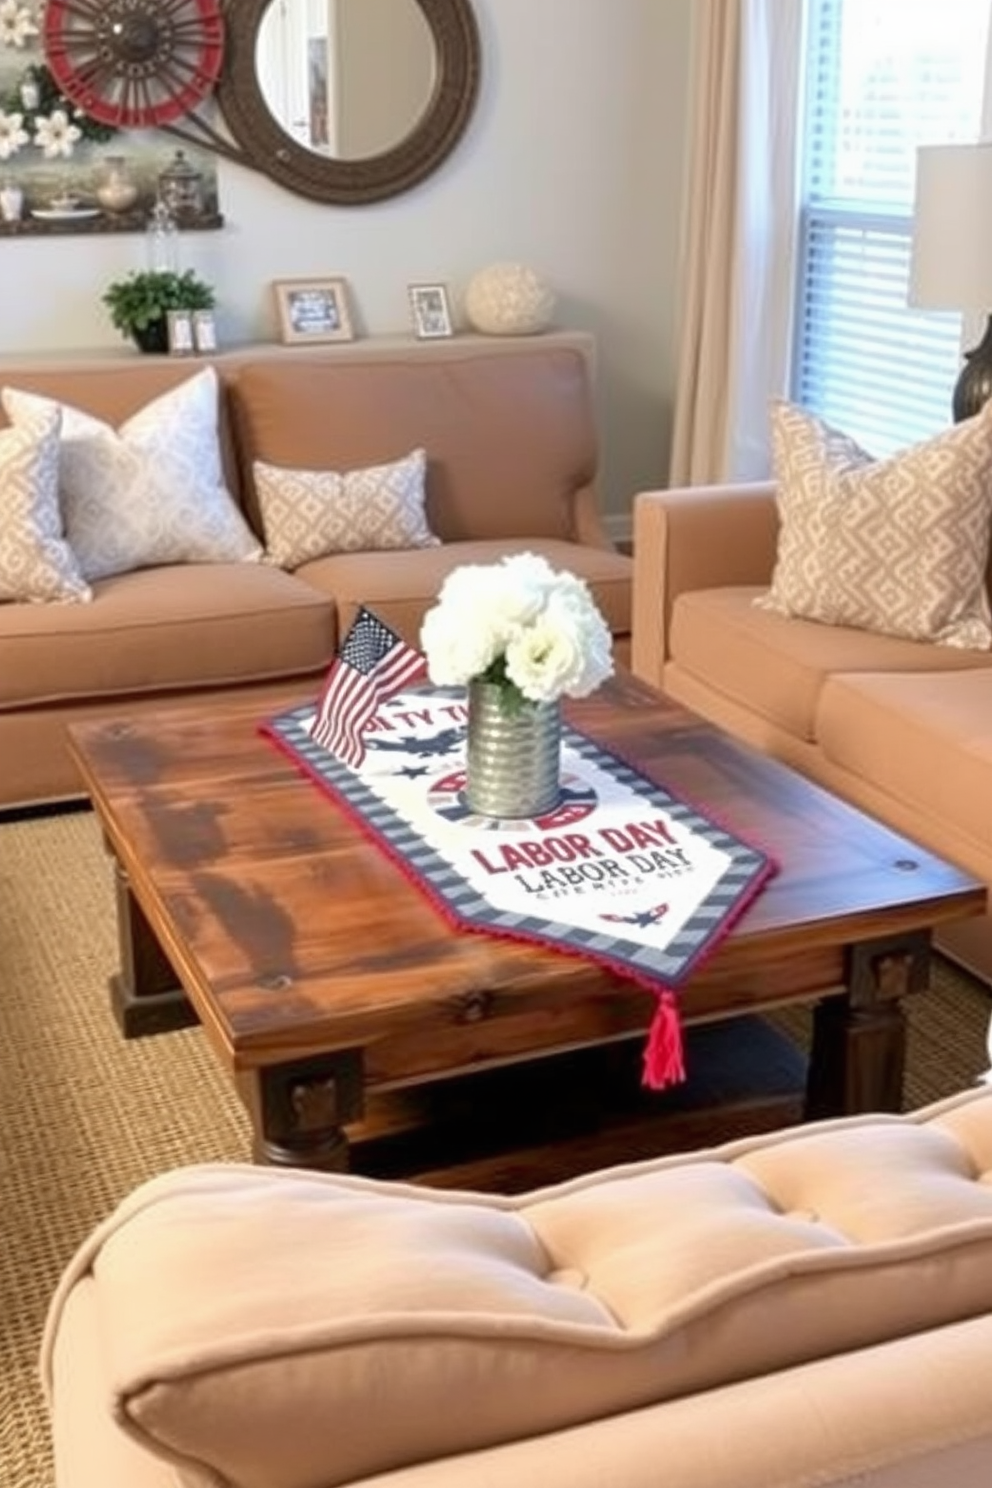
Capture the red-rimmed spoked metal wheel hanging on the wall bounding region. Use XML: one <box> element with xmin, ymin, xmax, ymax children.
<box><xmin>43</xmin><ymin>0</ymin><xmax>225</xmax><ymax>129</ymax></box>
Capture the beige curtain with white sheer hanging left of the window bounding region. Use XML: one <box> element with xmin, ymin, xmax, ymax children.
<box><xmin>669</xmin><ymin>0</ymin><xmax>803</xmax><ymax>485</ymax></box>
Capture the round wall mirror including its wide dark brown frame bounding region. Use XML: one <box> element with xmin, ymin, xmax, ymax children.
<box><xmin>217</xmin><ymin>0</ymin><xmax>479</xmax><ymax>205</ymax></box>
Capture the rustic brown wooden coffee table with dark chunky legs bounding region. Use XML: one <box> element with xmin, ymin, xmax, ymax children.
<box><xmin>70</xmin><ymin>674</ymin><xmax>986</xmax><ymax>1186</ymax></box>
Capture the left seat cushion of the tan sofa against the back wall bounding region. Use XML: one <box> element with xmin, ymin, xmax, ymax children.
<box><xmin>0</xmin><ymin>564</ymin><xmax>338</xmax><ymax>711</ymax></box>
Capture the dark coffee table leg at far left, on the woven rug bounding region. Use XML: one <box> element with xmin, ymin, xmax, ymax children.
<box><xmin>110</xmin><ymin>859</ymin><xmax>198</xmax><ymax>1039</ymax></box>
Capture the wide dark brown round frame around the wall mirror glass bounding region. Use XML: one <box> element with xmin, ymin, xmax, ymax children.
<box><xmin>216</xmin><ymin>0</ymin><xmax>480</xmax><ymax>207</ymax></box>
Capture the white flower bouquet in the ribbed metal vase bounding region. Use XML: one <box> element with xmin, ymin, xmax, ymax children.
<box><xmin>421</xmin><ymin>554</ymin><xmax>613</xmax><ymax>702</ymax></box>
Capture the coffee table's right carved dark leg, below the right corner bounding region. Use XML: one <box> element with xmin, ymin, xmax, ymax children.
<box><xmin>806</xmin><ymin>931</ymin><xmax>930</xmax><ymax>1120</ymax></box>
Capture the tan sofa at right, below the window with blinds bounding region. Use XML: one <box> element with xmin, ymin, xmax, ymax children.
<box><xmin>632</xmin><ymin>484</ymin><xmax>992</xmax><ymax>982</ymax></box>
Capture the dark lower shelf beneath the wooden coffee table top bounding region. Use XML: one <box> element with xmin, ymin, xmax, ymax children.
<box><xmin>330</xmin><ymin>1015</ymin><xmax>806</xmax><ymax>1193</ymax></box>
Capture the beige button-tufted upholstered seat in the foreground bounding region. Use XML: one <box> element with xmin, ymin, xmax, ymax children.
<box><xmin>43</xmin><ymin>1088</ymin><xmax>992</xmax><ymax>1488</ymax></box>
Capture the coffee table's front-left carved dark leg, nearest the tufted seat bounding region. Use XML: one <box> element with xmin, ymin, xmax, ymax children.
<box><xmin>235</xmin><ymin>1049</ymin><xmax>364</xmax><ymax>1173</ymax></box>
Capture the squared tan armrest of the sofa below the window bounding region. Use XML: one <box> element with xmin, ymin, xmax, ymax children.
<box><xmin>631</xmin><ymin>481</ymin><xmax>778</xmax><ymax>686</ymax></box>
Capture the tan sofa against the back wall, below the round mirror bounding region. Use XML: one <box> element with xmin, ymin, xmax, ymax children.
<box><xmin>0</xmin><ymin>332</ymin><xmax>632</xmax><ymax>806</ymax></box>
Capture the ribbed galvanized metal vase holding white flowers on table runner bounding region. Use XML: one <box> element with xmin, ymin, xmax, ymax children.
<box><xmin>466</xmin><ymin>680</ymin><xmax>561</xmax><ymax>818</ymax></box>
